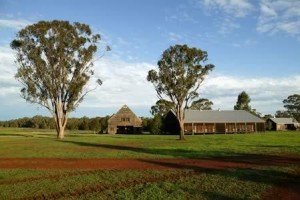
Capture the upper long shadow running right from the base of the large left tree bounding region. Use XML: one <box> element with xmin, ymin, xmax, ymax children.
<box><xmin>61</xmin><ymin>140</ymin><xmax>300</xmax><ymax>167</ymax></box>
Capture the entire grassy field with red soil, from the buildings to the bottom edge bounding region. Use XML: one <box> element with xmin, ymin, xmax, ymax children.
<box><xmin>0</xmin><ymin>128</ymin><xmax>300</xmax><ymax>199</ymax></box>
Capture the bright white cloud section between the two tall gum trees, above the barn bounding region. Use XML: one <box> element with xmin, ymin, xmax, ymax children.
<box><xmin>82</xmin><ymin>58</ymin><xmax>156</xmax><ymax>108</ymax></box>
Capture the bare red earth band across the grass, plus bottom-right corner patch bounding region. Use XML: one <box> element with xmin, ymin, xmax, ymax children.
<box><xmin>0</xmin><ymin>155</ymin><xmax>300</xmax><ymax>199</ymax></box>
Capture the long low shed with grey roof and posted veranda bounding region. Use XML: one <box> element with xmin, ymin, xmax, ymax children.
<box><xmin>165</xmin><ymin>110</ymin><xmax>265</xmax><ymax>134</ymax></box>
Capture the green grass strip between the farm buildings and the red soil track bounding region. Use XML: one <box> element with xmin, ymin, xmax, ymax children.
<box><xmin>0</xmin><ymin>129</ymin><xmax>300</xmax><ymax>158</ymax></box>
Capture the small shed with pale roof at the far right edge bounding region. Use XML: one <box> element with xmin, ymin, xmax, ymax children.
<box><xmin>266</xmin><ymin>118</ymin><xmax>300</xmax><ymax>131</ymax></box>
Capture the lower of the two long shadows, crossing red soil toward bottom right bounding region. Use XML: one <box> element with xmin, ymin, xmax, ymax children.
<box><xmin>139</xmin><ymin>159</ymin><xmax>300</xmax><ymax>199</ymax></box>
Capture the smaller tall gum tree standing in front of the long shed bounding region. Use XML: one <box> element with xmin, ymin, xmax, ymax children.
<box><xmin>147</xmin><ymin>45</ymin><xmax>214</xmax><ymax>140</ymax></box>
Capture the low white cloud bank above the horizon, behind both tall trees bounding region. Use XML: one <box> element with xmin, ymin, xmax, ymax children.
<box><xmin>0</xmin><ymin>45</ymin><xmax>300</xmax><ymax>116</ymax></box>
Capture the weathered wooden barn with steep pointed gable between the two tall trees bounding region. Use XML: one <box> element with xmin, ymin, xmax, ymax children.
<box><xmin>107</xmin><ymin>105</ymin><xmax>142</xmax><ymax>134</ymax></box>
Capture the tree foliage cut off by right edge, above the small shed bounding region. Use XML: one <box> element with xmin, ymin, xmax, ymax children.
<box><xmin>283</xmin><ymin>94</ymin><xmax>300</xmax><ymax>121</ymax></box>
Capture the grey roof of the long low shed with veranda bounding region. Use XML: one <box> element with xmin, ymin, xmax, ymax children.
<box><xmin>185</xmin><ymin>110</ymin><xmax>265</xmax><ymax>123</ymax></box>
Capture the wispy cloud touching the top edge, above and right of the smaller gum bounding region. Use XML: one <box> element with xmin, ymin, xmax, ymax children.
<box><xmin>200</xmin><ymin>0</ymin><xmax>253</xmax><ymax>17</ymax></box>
